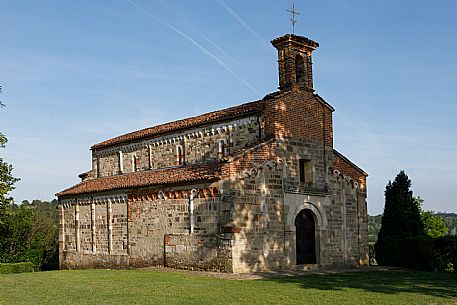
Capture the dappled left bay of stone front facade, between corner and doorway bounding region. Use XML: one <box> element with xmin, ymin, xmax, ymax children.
<box><xmin>230</xmin><ymin>161</ymin><xmax>284</xmax><ymax>272</ymax></box>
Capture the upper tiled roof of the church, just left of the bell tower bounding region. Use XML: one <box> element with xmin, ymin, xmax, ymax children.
<box><xmin>92</xmin><ymin>96</ymin><xmax>269</xmax><ymax>149</ymax></box>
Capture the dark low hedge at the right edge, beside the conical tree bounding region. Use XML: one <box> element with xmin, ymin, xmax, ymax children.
<box><xmin>375</xmin><ymin>236</ymin><xmax>457</xmax><ymax>273</ymax></box>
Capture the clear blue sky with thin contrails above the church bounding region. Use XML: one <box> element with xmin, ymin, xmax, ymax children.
<box><xmin>0</xmin><ymin>0</ymin><xmax>457</xmax><ymax>214</ymax></box>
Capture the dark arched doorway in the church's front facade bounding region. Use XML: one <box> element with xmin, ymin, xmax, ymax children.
<box><xmin>295</xmin><ymin>209</ymin><xmax>316</xmax><ymax>265</ymax></box>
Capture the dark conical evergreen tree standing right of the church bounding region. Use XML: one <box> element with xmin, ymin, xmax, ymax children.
<box><xmin>375</xmin><ymin>171</ymin><xmax>424</xmax><ymax>266</ymax></box>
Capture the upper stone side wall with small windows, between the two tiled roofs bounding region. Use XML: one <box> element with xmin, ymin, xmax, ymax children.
<box><xmin>92</xmin><ymin>116</ymin><xmax>260</xmax><ymax>177</ymax></box>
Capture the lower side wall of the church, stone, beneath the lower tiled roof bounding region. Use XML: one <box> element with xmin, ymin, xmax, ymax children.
<box><xmin>60</xmin><ymin>184</ymin><xmax>232</xmax><ymax>272</ymax></box>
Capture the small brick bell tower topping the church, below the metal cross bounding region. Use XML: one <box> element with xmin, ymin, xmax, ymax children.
<box><xmin>271</xmin><ymin>34</ymin><xmax>319</xmax><ymax>92</ymax></box>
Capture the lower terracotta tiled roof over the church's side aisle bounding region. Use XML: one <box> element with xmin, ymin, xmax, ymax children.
<box><xmin>56</xmin><ymin>163</ymin><xmax>220</xmax><ymax>197</ymax></box>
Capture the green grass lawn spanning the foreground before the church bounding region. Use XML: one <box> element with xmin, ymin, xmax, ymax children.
<box><xmin>0</xmin><ymin>270</ymin><xmax>457</xmax><ymax>305</ymax></box>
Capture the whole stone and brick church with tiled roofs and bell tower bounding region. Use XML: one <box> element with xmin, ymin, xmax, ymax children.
<box><xmin>56</xmin><ymin>34</ymin><xmax>368</xmax><ymax>273</ymax></box>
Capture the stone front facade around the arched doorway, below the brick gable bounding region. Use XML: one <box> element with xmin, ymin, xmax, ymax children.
<box><xmin>226</xmin><ymin>138</ymin><xmax>368</xmax><ymax>272</ymax></box>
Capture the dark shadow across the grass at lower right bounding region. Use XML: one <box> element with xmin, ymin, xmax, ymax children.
<box><xmin>260</xmin><ymin>271</ymin><xmax>457</xmax><ymax>298</ymax></box>
